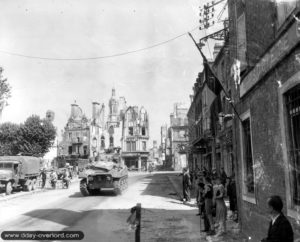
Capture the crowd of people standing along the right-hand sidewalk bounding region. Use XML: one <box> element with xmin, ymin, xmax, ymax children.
<box><xmin>183</xmin><ymin>168</ymin><xmax>237</xmax><ymax>235</ymax></box>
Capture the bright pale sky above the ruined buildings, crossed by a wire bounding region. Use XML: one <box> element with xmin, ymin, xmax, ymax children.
<box><xmin>0</xmin><ymin>0</ymin><xmax>225</xmax><ymax>144</ymax></box>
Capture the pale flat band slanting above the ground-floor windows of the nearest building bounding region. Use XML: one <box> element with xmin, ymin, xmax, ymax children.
<box><xmin>240</xmin><ymin>22</ymin><xmax>300</xmax><ymax>97</ymax></box>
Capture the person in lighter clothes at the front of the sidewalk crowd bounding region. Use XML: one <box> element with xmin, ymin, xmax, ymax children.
<box><xmin>215</xmin><ymin>177</ymin><xmax>227</xmax><ymax>236</ymax></box>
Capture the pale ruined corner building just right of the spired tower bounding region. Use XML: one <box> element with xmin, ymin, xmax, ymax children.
<box><xmin>121</xmin><ymin>106</ymin><xmax>149</xmax><ymax>171</ymax></box>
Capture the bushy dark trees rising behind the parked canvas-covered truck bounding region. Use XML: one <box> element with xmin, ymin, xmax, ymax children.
<box><xmin>0</xmin><ymin>115</ymin><xmax>56</xmax><ymax>156</ymax></box>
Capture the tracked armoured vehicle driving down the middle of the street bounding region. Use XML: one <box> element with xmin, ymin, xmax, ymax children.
<box><xmin>79</xmin><ymin>153</ymin><xmax>128</xmax><ymax>196</ymax></box>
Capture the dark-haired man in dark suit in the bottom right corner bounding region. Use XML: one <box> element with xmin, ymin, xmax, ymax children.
<box><xmin>262</xmin><ymin>196</ymin><xmax>294</xmax><ymax>242</ymax></box>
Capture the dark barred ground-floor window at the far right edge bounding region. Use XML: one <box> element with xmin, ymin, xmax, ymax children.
<box><xmin>285</xmin><ymin>85</ymin><xmax>300</xmax><ymax>205</ymax></box>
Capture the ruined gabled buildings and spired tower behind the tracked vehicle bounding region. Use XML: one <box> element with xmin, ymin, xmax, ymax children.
<box><xmin>58</xmin><ymin>88</ymin><xmax>126</xmax><ymax>163</ymax></box>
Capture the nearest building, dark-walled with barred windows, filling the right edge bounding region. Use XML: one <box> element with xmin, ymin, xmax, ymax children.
<box><xmin>228</xmin><ymin>0</ymin><xmax>300</xmax><ymax>241</ymax></box>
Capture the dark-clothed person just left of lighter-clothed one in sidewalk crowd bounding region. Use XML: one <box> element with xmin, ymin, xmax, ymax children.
<box><xmin>203</xmin><ymin>177</ymin><xmax>215</xmax><ymax>235</ymax></box>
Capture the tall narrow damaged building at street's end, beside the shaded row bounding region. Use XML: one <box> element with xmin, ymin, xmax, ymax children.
<box><xmin>167</xmin><ymin>103</ymin><xmax>188</xmax><ymax>171</ymax></box>
